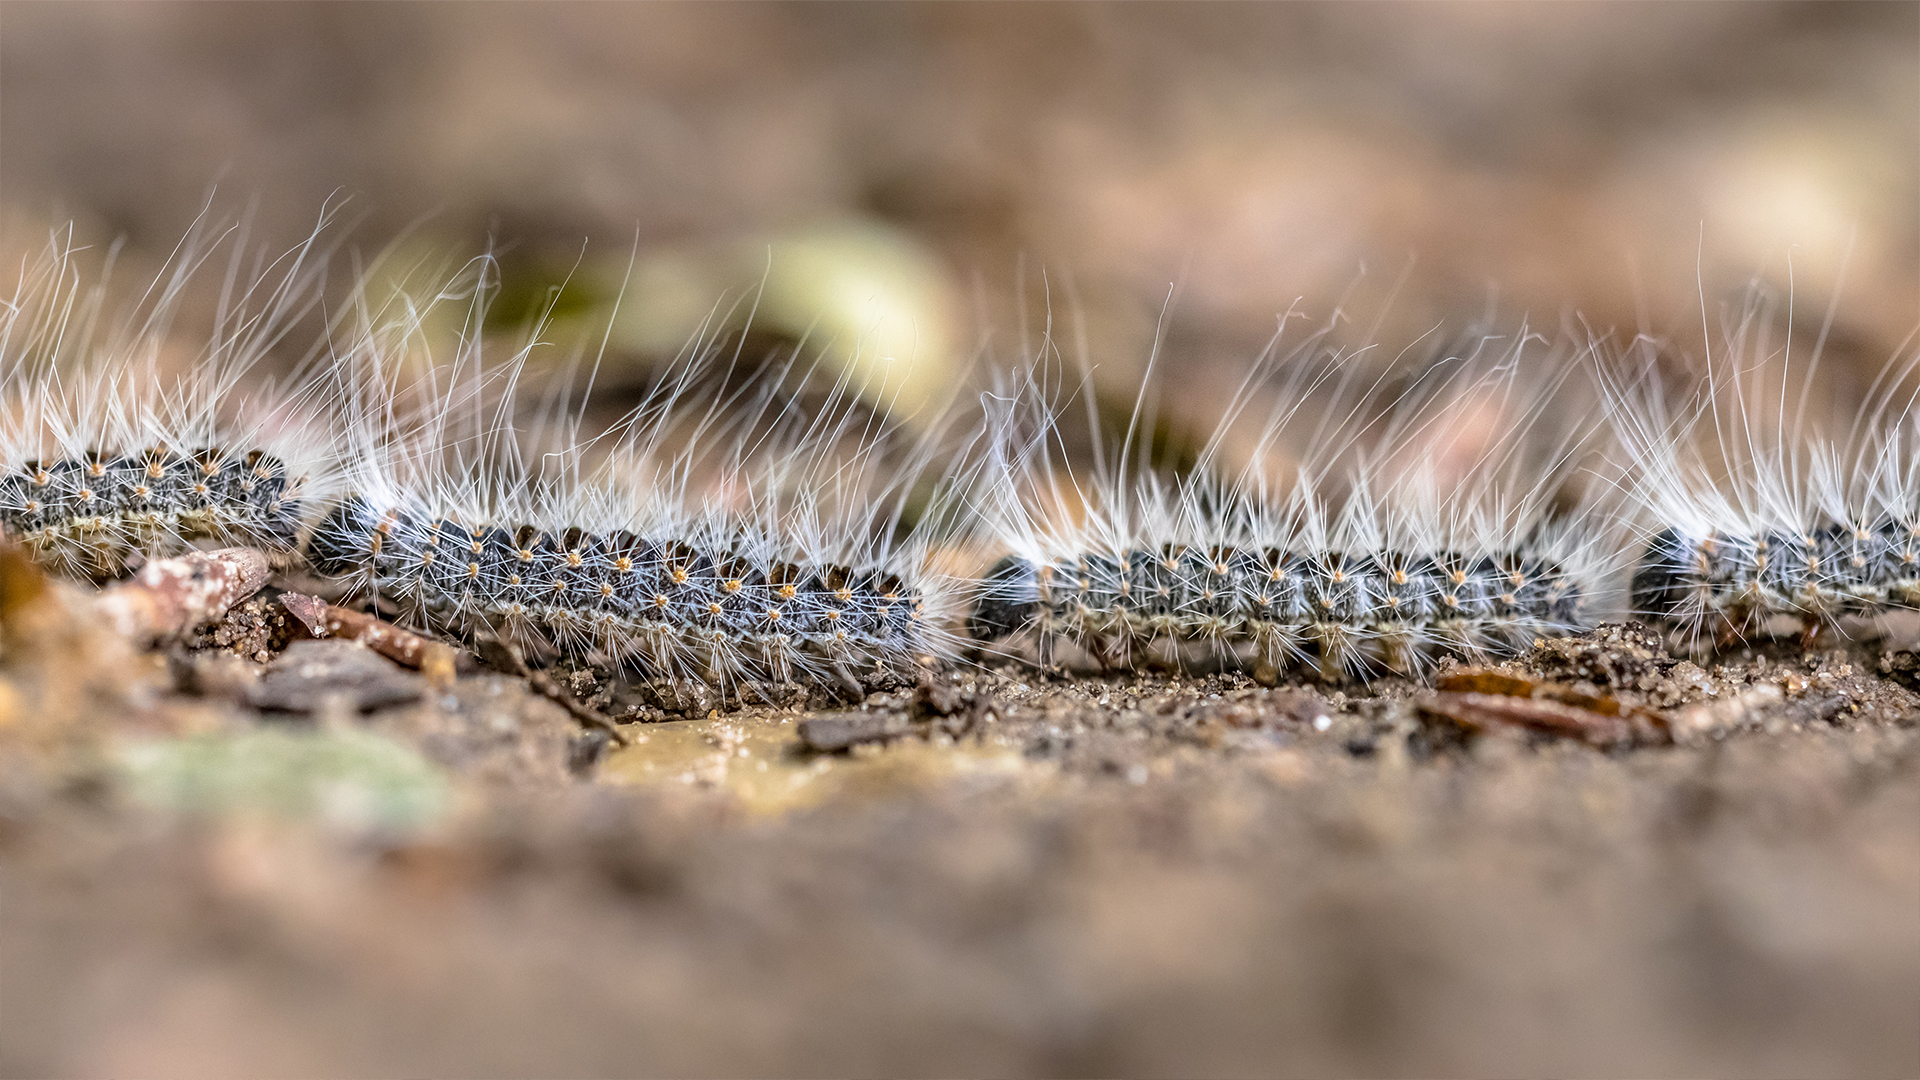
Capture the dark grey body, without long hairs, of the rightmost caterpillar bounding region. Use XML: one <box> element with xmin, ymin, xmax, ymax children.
<box><xmin>1632</xmin><ymin>513</ymin><xmax>1920</xmax><ymax>640</ymax></box>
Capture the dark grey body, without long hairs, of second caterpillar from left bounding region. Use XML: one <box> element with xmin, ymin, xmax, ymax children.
<box><xmin>309</xmin><ymin>498</ymin><xmax>937</xmax><ymax>690</ymax></box>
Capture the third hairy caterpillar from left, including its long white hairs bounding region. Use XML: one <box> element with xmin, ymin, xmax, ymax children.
<box><xmin>970</xmin><ymin>307</ymin><xmax>1620</xmax><ymax>680</ymax></box>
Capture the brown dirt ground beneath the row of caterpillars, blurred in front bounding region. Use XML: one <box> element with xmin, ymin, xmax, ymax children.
<box><xmin>0</xmin><ymin>609</ymin><xmax>1920</xmax><ymax>1076</ymax></box>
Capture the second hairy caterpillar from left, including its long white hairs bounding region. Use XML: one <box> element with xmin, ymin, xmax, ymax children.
<box><xmin>309</xmin><ymin>258</ymin><xmax>983</xmax><ymax>692</ymax></box>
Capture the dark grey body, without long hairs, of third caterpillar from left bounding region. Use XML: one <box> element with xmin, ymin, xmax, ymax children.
<box><xmin>970</xmin><ymin>544</ymin><xmax>1584</xmax><ymax>680</ymax></box>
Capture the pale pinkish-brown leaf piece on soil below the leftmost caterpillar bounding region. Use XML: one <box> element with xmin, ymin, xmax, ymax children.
<box><xmin>94</xmin><ymin>548</ymin><xmax>271</xmax><ymax>642</ymax></box>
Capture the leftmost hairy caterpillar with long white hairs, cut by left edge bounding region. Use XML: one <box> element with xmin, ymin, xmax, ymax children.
<box><xmin>0</xmin><ymin>202</ymin><xmax>334</xmax><ymax>578</ymax></box>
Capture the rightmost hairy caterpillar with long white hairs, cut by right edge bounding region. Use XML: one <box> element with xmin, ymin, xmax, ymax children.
<box><xmin>1596</xmin><ymin>278</ymin><xmax>1920</xmax><ymax>651</ymax></box>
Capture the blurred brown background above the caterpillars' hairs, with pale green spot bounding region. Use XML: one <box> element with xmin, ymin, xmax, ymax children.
<box><xmin>0</xmin><ymin>2</ymin><xmax>1920</xmax><ymax>434</ymax></box>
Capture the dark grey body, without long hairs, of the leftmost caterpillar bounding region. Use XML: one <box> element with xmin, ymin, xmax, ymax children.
<box><xmin>0</xmin><ymin>448</ymin><xmax>303</xmax><ymax>578</ymax></box>
